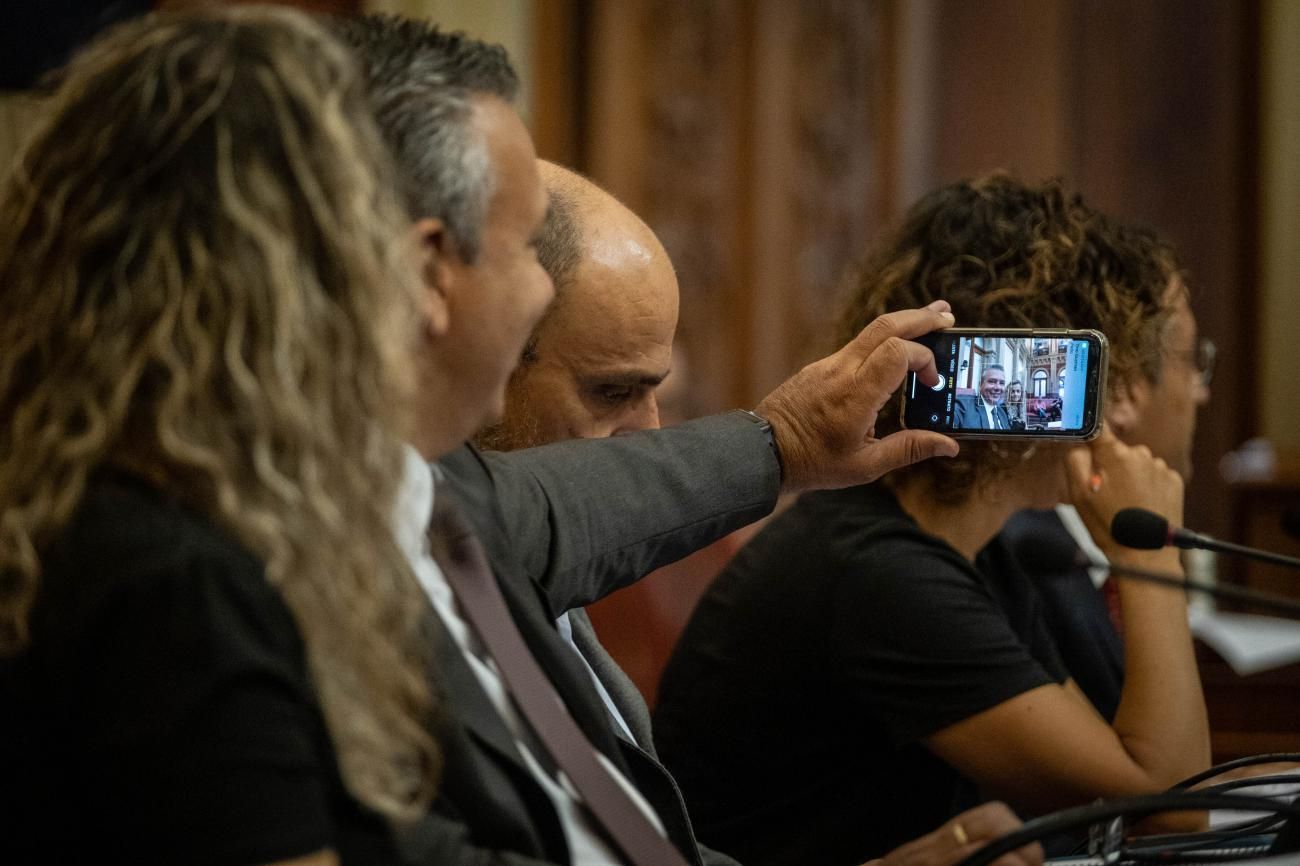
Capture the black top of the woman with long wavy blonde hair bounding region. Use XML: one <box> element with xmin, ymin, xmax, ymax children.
<box><xmin>0</xmin><ymin>480</ymin><xmax>397</xmax><ymax>865</ymax></box>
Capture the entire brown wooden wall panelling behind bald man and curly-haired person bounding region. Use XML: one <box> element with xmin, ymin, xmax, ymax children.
<box><xmin>559</xmin><ymin>0</ymin><xmax>1258</xmax><ymax>707</ymax></box>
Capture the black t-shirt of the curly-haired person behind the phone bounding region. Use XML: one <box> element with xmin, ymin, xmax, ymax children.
<box><xmin>654</xmin><ymin>485</ymin><xmax>1066</xmax><ymax>866</ymax></box>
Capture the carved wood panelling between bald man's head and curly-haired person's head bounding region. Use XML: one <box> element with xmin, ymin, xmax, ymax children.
<box><xmin>585</xmin><ymin>0</ymin><xmax>891</xmax><ymax>412</ymax></box>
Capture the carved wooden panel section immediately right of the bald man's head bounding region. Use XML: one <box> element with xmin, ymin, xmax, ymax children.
<box><xmin>585</xmin><ymin>0</ymin><xmax>750</xmax><ymax>410</ymax></box>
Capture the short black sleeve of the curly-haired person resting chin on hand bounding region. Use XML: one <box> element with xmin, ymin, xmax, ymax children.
<box><xmin>828</xmin><ymin>540</ymin><xmax>1058</xmax><ymax>744</ymax></box>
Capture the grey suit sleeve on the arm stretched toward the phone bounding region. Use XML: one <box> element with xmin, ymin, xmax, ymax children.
<box><xmin>438</xmin><ymin>412</ymin><xmax>780</xmax><ymax>615</ymax></box>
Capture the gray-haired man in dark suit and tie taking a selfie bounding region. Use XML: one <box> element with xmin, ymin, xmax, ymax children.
<box><xmin>337</xmin><ymin>17</ymin><xmax>1040</xmax><ymax>866</ymax></box>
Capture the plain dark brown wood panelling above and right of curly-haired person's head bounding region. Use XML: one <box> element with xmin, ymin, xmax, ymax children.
<box><xmin>920</xmin><ymin>0</ymin><xmax>1258</xmax><ymax>533</ymax></box>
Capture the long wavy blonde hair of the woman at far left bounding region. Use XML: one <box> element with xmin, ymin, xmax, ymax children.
<box><xmin>0</xmin><ymin>8</ymin><xmax>438</xmax><ymax>818</ymax></box>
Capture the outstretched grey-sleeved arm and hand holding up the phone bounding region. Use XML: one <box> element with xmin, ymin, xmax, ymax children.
<box><xmin>439</xmin><ymin>302</ymin><xmax>957</xmax><ymax>614</ymax></box>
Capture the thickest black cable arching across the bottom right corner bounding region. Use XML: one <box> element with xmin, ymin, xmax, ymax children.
<box><xmin>957</xmin><ymin>791</ymin><xmax>1300</xmax><ymax>866</ymax></box>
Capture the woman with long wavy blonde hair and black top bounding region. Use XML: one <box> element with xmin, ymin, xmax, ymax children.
<box><xmin>0</xmin><ymin>9</ymin><xmax>439</xmax><ymax>863</ymax></box>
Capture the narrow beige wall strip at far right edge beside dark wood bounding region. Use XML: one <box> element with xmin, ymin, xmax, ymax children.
<box><xmin>1258</xmin><ymin>0</ymin><xmax>1300</xmax><ymax>451</ymax></box>
